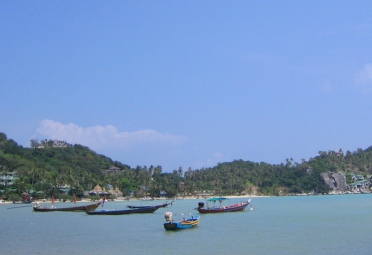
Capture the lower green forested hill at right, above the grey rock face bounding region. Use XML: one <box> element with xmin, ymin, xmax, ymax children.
<box><xmin>193</xmin><ymin>147</ymin><xmax>372</xmax><ymax>195</ymax></box>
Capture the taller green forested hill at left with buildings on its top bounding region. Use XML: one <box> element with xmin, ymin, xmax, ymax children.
<box><xmin>0</xmin><ymin>133</ymin><xmax>130</xmax><ymax>199</ymax></box>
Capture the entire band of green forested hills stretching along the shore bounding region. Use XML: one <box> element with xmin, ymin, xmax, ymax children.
<box><xmin>0</xmin><ymin>133</ymin><xmax>372</xmax><ymax>197</ymax></box>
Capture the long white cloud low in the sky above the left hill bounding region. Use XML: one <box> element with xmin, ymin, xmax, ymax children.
<box><xmin>37</xmin><ymin>120</ymin><xmax>186</xmax><ymax>150</ymax></box>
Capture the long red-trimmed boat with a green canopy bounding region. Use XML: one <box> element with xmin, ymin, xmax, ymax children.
<box><xmin>195</xmin><ymin>197</ymin><xmax>252</xmax><ymax>213</ymax></box>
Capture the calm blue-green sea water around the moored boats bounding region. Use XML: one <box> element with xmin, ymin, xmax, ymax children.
<box><xmin>0</xmin><ymin>194</ymin><xmax>372</xmax><ymax>255</ymax></box>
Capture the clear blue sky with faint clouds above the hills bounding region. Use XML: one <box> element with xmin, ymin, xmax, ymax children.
<box><xmin>0</xmin><ymin>0</ymin><xmax>372</xmax><ymax>172</ymax></box>
